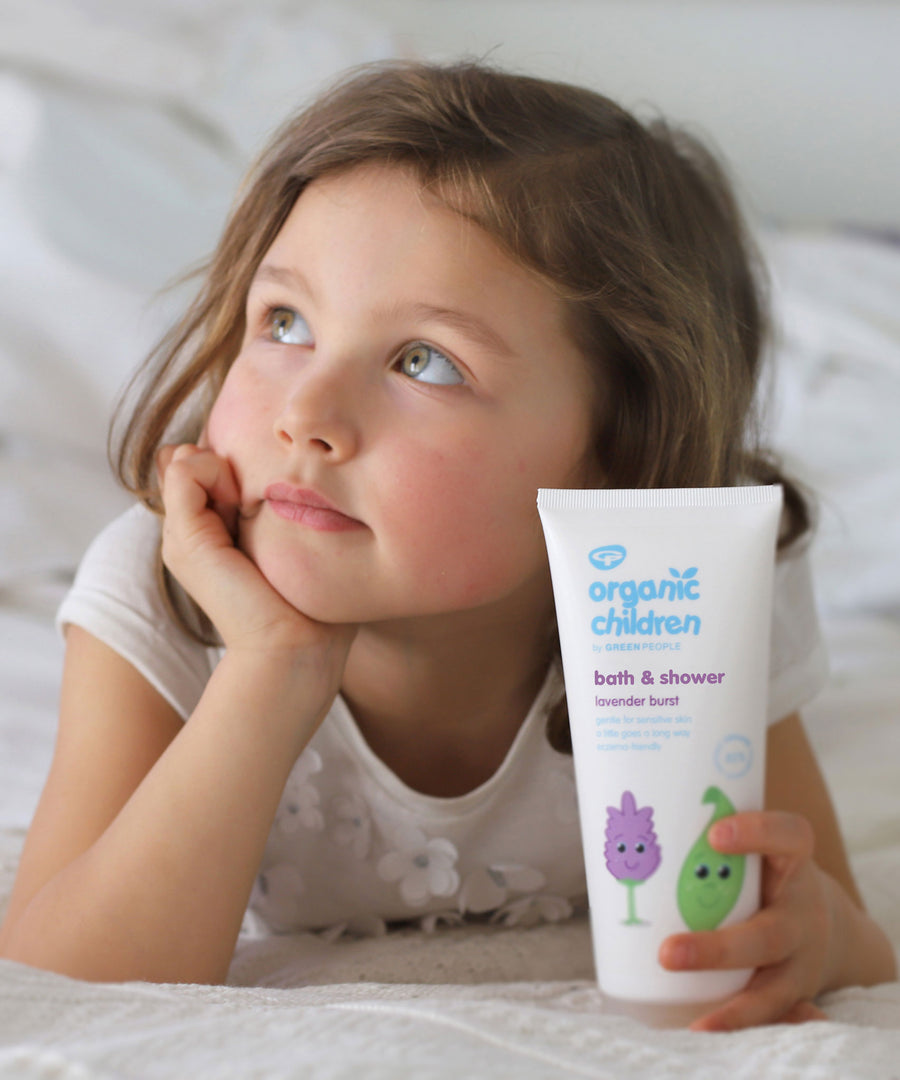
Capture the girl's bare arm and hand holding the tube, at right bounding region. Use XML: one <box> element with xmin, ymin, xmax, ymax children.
<box><xmin>660</xmin><ymin>714</ymin><xmax>897</xmax><ymax>1030</ymax></box>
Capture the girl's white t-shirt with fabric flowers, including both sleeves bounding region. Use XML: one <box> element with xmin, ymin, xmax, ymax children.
<box><xmin>57</xmin><ymin>505</ymin><xmax>827</xmax><ymax>933</ymax></box>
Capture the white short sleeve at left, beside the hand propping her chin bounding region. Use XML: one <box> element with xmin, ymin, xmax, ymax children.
<box><xmin>56</xmin><ymin>504</ymin><xmax>213</xmax><ymax>719</ymax></box>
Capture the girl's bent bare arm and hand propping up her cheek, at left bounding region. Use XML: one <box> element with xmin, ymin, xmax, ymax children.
<box><xmin>0</xmin><ymin>442</ymin><xmax>352</xmax><ymax>982</ymax></box>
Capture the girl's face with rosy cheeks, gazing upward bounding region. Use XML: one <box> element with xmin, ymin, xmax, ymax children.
<box><xmin>206</xmin><ymin>166</ymin><xmax>595</xmax><ymax>622</ymax></box>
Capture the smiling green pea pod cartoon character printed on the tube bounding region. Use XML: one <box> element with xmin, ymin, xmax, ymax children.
<box><xmin>677</xmin><ymin>786</ymin><xmax>744</xmax><ymax>931</ymax></box>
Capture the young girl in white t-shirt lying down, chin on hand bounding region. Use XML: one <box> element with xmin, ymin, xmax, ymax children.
<box><xmin>0</xmin><ymin>64</ymin><xmax>894</xmax><ymax>1029</ymax></box>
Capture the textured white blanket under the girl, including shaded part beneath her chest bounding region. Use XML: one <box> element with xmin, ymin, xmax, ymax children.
<box><xmin>0</xmin><ymin>812</ymin><xmax>900</xmax><ymax>1080</ymax></box>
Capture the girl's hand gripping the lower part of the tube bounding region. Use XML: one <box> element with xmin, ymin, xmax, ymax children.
<box><xmin>659</xmin><ymin>810</ymin><xmax>836</xmax><ymax>1031</ymax></box>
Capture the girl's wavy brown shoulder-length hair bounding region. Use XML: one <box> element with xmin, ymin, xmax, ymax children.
<box><xmin>111</xmin><ymin>62</ymin><xmax>809</xmax><ymax>745</ymax></box>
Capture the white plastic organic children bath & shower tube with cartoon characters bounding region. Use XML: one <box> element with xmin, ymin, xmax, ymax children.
<box><xmin>538</xmin><ymin>486</ymin><xmax>782</xmax><ymax>1024</ymax></box>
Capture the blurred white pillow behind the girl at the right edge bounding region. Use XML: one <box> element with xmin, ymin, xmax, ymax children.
<box><xmin>765</xmin><ymin>223</ymin><xmax>900</xmax><ymax>617</ymax></box>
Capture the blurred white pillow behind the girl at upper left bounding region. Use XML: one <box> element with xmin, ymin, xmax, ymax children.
<box><xmin>0</xmin><ymin>0</ymin><xmax>392</xmax><ymax>591</ymax></box>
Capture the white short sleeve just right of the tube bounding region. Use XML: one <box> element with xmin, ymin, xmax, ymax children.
<box><xmin>768</xmin><ymin>548</ymin><xmax>829</xmax><ymax>724</ymax></box>
